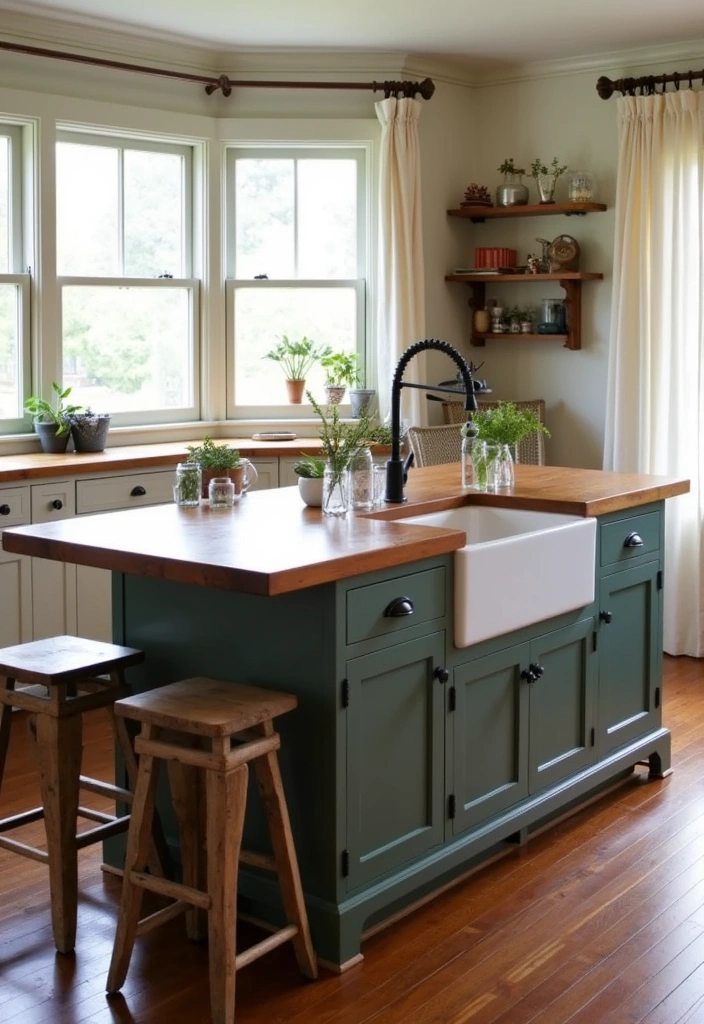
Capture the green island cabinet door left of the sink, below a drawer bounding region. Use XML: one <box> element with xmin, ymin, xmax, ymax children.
<box><xmin>347</xmin><ymin>633</ymin><xmax>445</xmax><ymax>889</ymax></box>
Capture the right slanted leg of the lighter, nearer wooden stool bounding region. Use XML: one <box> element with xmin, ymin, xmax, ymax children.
<box><xmin>255</xmin><ymin>722</ymin><xmax>318</xmax><ymax>978</ymax></box>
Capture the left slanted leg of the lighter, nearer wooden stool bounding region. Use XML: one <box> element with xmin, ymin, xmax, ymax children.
<box><xmin>106</xmin><ymin>725</ymin><xmax>159</xmax><ymax>993</ymax></box>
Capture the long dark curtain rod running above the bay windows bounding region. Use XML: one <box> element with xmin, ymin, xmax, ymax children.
<box><xmin>0</xmin><ymin>41</ymin><xmax>435</xmax><ymax>99</ymax></box>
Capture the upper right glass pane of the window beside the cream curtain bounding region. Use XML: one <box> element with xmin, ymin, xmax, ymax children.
<box><xmin>298</xmin><ymin>160</ymin><xmax>357</xmax><ymax>280</ymax></box>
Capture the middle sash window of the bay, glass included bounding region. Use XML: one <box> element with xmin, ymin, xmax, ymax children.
<box><xmin>56</xmin><ymin>131</ymin><xmax>200</xmax><ymax>424</ymax></box>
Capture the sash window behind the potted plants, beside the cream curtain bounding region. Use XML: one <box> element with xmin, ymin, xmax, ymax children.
<box><xmin>227</xmin><ymin>145</ymin><xmax>367</xmax><ymax>418</ymax></box>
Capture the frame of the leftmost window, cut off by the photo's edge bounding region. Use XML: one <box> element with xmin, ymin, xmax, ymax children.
<box><xmin>0</xmin><ymin>118</ymin><xmax>32</xmax><ymax>435</ymax></box>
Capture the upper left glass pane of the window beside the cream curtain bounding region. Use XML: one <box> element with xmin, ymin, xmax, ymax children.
<box><xmin>234</xmin><ymin>159</ymin><xmax>295</xmax><ymax>280</ymax></box>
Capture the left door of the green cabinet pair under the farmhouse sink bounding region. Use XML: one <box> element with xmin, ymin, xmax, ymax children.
<box><xmin>451</xmin><ymin>643</ymin><xmax>529</xmax><ymax>834</ymax></box>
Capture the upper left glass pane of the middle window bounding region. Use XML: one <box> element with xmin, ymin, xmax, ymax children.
<box><xmin>56</xmin><ymin>142</ymin><xmax>120</xmax><ymax>278</ymax></box>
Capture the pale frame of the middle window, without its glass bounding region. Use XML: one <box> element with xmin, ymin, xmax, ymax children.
<box><xmin>54</xmin><ymin>124</ymin><xmax>203</xmax><ymax>427</ymax></box>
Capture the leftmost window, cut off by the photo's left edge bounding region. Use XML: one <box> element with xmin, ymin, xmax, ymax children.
<box><xmin>0</xmin><ymin>124</ymin><xmax>30</xmax><ymax>433</ymax></box>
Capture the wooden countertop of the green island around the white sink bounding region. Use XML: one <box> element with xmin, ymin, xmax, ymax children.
<box><xmin>2</xmin><ymin>464</ymin><xmax>689</xmax><ymax>595</ymax></box>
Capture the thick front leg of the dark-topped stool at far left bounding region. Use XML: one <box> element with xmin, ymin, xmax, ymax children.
<box><xmin>36</xmin><ymin>715</ymin><xmax>82</xmax><ymax>953</ymax></box>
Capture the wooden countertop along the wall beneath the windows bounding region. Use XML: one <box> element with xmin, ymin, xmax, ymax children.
<box><xmin>0</xmin><ymin>436</ymin><xmax>321</xmax><ymax>484</ymax></box>
